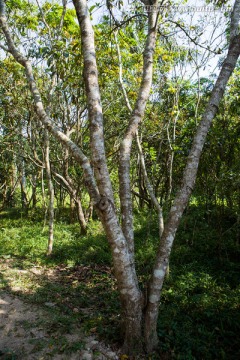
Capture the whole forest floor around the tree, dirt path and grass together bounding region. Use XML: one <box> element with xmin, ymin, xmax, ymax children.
<box><xmin>0</xmin><ymin>210</ymin><xmax>240</xmax><ymax>360</ymax></box>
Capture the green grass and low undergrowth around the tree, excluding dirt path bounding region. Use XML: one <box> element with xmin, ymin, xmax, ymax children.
<box><xmin>0</xmin><ymin>206</ymin><xmax>240</xmax><ymax>360</ymax></box>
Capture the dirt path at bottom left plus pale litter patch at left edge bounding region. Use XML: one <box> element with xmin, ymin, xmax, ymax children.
<box><xmin>0</xmin><ymin>261</ymin><xmax>119</xmax><ymax>360</ymax></box>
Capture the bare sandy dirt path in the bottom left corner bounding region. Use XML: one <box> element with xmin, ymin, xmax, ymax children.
<box><xmin>0</xmin><ymin>290</ymin><xmax>119</xmax><ymax>360</ymax></box>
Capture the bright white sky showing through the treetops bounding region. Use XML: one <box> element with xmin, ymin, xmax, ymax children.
<box><xmin>88</xmin><ymin>0</ymin><xmax>233</xmax><ymax>77</ymax></box>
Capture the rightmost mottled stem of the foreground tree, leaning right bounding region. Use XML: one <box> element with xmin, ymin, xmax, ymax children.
<box><xmin>145</xmin><ymin>31</ymin><xmax>240</xmax><ymax>351</ymax></box>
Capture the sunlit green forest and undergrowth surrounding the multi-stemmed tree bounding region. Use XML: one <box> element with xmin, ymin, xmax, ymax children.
<box><xmin>0</xmin><ymin>0</ymin><xmax>240</xmax><ymax>359</ymax></box>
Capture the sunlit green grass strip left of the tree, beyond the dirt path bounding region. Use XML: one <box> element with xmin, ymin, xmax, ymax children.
<box><xmin>0</xmin><ymin>208</ymin><xmax>111</xmax><ymax>267</ymax></box>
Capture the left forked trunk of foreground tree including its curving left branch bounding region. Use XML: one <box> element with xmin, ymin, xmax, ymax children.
<box><xmin>0</xmin><ymin>1</ymin><xmax>143</xmax><ymax>352</ymax></box>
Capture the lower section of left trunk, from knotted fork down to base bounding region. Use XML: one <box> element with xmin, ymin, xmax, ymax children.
<box><xmin>97</xmin><ymin>197</ymin><xmax>144</xmax><ymax>354</ymax></box>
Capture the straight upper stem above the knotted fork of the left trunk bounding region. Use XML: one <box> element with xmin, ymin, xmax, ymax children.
<box><xmin>73</xmin><ymin>0</ymin><xmax>113</xmax><ymax>200</ymax></box>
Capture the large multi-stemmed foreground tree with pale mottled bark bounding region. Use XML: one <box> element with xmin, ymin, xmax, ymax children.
<box><xmin>0</xmin><ymin>0</ymin><xmax>240</xmax><ymax>354</ymax></box>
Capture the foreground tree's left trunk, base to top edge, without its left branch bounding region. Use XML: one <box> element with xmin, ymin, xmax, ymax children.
<box><xmin>73</xmin><ymin>0</ymin><xmax>142</xmax><ymax>352</ymax></box>
